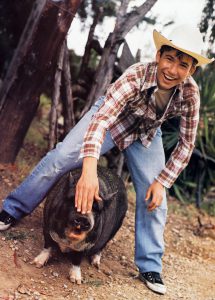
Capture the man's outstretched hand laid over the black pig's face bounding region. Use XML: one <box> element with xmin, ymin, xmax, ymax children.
<box><xmin>75</xmin><ymin>157</ymin><xmax>102</xmax><ymax>214</ymax></box>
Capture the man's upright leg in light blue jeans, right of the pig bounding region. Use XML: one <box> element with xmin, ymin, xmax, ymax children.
<box><xmin>124</xmin><ymin>129</ymin><xmax>167</xmax><ymax>292</ymax></box>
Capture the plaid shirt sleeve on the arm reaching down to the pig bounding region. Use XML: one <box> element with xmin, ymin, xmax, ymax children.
<box><xmin>79</xmin><ymin>64</ymin><xmax>143</xmax><ymax>159</ymax></box>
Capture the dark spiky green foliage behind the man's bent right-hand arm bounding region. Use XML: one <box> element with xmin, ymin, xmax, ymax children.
<box><xmin>163</xmin><ymin>65</ymin><xmax>215</xmax><ymax>206</ymax></box>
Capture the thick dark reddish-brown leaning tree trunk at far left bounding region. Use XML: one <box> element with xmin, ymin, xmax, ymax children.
<box><xmin>0</xmin><ymin>0</ymin><xmax>81</xmax><ymax>163</ymax></box>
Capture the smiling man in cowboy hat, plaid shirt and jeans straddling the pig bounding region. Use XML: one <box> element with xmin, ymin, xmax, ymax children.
<box><xmin>0</xmin><ymin>25</ymin><xmax>213</xmax><ymax>294</ymax></box>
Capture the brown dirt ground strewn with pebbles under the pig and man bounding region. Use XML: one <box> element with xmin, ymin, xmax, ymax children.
<box><xmin>0</xmin><ymin>162</ymin><xmax>215</xmax><ymax>300</ymax></box>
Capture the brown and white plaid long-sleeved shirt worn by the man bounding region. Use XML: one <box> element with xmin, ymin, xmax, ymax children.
<box><xmin>80</xmin><ymin>62</ymin><xmax>200</xmax><ymax>188</ymax></box>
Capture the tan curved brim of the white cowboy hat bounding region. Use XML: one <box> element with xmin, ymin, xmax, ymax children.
<box><xmin>153</xmin><ymin>30</ymin><xmax>214</xmax><ymax>66</ymax></box>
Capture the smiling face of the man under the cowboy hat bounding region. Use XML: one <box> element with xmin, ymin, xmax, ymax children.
<box><xmin>156</xmin><ymin>50</ymin><xmax>195</xmax><ymax>90</ymax></box>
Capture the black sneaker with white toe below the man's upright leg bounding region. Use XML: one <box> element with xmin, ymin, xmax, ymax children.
<box><xmin>139</xmin><ymin>272</ymin><xmax>166</xmax><ymax>295</ymax></box>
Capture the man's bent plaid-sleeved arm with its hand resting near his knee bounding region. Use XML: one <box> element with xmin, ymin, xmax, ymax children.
<box><xmin>145</xmin><ymin>84</ymin><xmax>200</xmax><ymax>210</ymax></box>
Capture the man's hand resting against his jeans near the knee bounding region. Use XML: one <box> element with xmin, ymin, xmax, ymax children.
<box><xmin>145</xmin><ymin>180</ymin><xmax>164</xmax><ymax>211</ymax></box>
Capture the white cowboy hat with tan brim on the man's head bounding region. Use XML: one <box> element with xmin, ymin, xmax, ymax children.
<box><xmin>153</xmin><ymin>25</ymin><xmax>214</xmax><ymax>66</ymax></box>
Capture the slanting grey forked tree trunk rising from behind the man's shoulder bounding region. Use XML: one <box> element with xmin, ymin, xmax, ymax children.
<box><xmin>82</xmin><ymin>0</ymin><xmax>157</xmax><ymax>115</ymax></box>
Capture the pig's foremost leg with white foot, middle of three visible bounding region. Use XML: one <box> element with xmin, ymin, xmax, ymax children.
<box><xmin>69</xmin><ymin>252</ymin><xmax>83</xmax><ymax>284</ymax></box>
